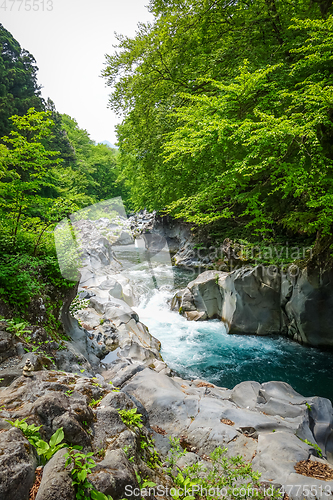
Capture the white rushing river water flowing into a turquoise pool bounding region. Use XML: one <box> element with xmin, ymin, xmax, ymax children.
<box><xmin>113</xmin><ymin>244</ymin><xmax>333</xmax><ymax>401</ymax></box>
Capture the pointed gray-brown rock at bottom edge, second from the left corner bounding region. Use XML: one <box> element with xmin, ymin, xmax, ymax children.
<box><xmin>36</xmin><ymin>448</ymin><xmax>76</xmax><ymax>500</ymax></box>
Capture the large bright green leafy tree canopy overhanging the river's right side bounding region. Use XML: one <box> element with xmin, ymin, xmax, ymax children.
<box><xmin>103</xmin><ymin>0</ymin><xmax>333</xmax><ymax>239</ymax></box>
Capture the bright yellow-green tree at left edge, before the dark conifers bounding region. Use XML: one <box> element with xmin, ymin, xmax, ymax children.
<box><xmin>0</xmin><ymin>108</ymin><xmax>61</xmax><ymax>249</ymax></box>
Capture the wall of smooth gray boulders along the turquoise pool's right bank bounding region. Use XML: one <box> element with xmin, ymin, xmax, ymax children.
<box><xmin>172</xmin><ymin>266</ymin><xmax>333</xmax><ymax>347</ymax></box>
